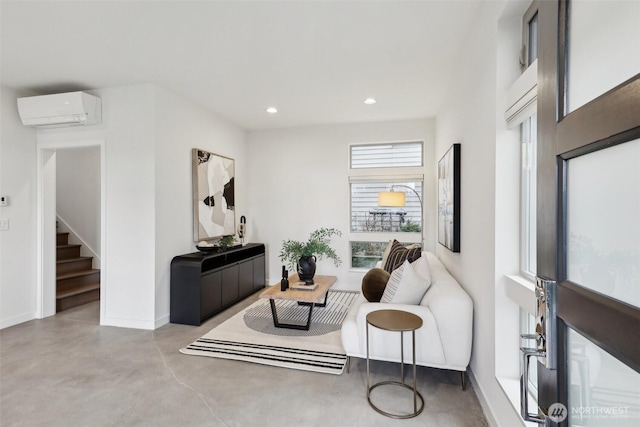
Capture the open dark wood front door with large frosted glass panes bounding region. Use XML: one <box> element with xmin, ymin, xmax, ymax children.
<box><xmin>537</xmin><ymin>0</ymin><xmax>640</xmax><ymax>426</ymax></box>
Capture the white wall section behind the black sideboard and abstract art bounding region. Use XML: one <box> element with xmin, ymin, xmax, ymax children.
<box><xmin>155</xmin><ymin>88</ymin><xmax>246</xmax><ymax>326</ymax></box>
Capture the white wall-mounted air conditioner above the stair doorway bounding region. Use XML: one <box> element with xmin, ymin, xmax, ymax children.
<box><xmin>18</xmin><ymin>92</ymin><xmax>102</xmax><ymax>127</ymax></box>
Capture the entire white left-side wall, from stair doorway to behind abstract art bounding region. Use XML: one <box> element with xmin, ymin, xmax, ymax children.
<box><xmin>0</xmin><ymin>85</ymin><xmax>251</xmax><ymax>329</ymax></box>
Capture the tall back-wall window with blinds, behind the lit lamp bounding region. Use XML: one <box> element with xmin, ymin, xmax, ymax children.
<box><xmin>349</xmin><ymin>142</ymin><xmax>423</xmax><ymax>269</ymax></box>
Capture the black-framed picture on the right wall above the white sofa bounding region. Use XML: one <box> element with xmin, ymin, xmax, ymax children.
<box><xmin>438</xmin><ymin>144</ymin><xmax>461</xmax><ymax>252</ymax></box>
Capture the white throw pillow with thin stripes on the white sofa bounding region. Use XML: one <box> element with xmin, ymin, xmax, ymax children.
<box><xmin>380</xmin><ymin>260</ymin><xmax>431</xmax><ymax>305</ymax></box>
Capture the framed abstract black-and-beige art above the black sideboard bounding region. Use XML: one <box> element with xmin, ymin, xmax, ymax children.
<box><xmin>191</xmin><ymin>148</ymin><xmax>236</xmax><ymax>242</ymax></box>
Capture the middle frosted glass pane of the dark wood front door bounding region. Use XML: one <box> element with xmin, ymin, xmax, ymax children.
<box><xmin>567</xmin><ymin>139</ymin><xmax>640</xmax><ymax>307</ymax></box>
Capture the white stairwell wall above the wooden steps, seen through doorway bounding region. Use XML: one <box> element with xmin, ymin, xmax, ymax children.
<box><xmin>56</xmin><ymin>147</ymin><xmax>101</xmax><ymax>268</ymax></box>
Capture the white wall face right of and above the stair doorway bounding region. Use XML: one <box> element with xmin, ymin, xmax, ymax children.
<box><xmin>38</xmin><ymin>85</ymin><xmax>156</xmax><ymax>329</ymax></box>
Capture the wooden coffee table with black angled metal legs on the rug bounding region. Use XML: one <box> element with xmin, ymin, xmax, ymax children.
<box><xmin>260</xmin><ymin>274</ymin><xmax>336</xmax><ymax>331</ymax></box>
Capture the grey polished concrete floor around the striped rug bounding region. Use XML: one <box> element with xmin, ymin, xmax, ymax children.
<box><xmin>0</xmin><ymin>295</ymin><xmax>487</xmax><ymax>427</ymax></box>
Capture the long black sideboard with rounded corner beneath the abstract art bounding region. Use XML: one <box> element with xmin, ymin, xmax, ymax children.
<box><xmin>169</xmin><ymin>243</ymin><xmax>265</xmax><ymax>325</ymax></box>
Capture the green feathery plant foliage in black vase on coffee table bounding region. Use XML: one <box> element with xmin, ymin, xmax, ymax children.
<box><xmin>280</xmin><ymin>228</ymin><xmax>342</xmax><ymax>271</ymax></box>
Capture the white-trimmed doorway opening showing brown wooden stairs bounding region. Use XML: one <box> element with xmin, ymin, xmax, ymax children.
<box><xmin>36</xmin><ymin>140</ymin><xmax>106</xmax><ymax>323</ymax></box>
